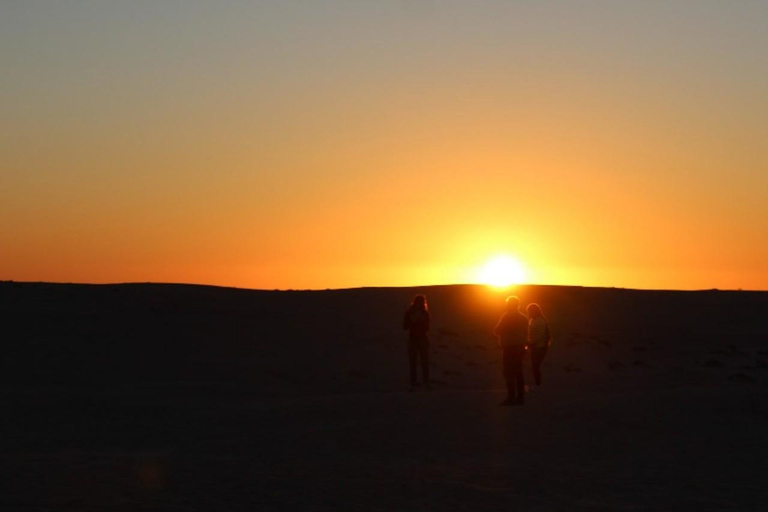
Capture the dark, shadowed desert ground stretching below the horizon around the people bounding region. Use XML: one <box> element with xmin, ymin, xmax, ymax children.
<box><xmin>0</xmin><ymin>282</ymin><xmax>768</xmax><ymax>511</ymax></box>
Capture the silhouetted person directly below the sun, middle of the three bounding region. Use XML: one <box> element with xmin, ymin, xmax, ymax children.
<box><xmin>494</xmin><ymin>296</ymin><xmax>528</xmax><ymax>405</ymax></box>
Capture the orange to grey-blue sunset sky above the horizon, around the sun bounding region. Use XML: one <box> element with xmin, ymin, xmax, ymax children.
<box><xmin>0</xmin><ymin>0</ymin><xmax>768</xmax><ymax>290</ymax></box>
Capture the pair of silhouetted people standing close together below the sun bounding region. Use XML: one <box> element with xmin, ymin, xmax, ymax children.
<box><xmin>494</xmin><ymin>296</ymin><xmax>550</xmax><ymax>405</ymax></box>
